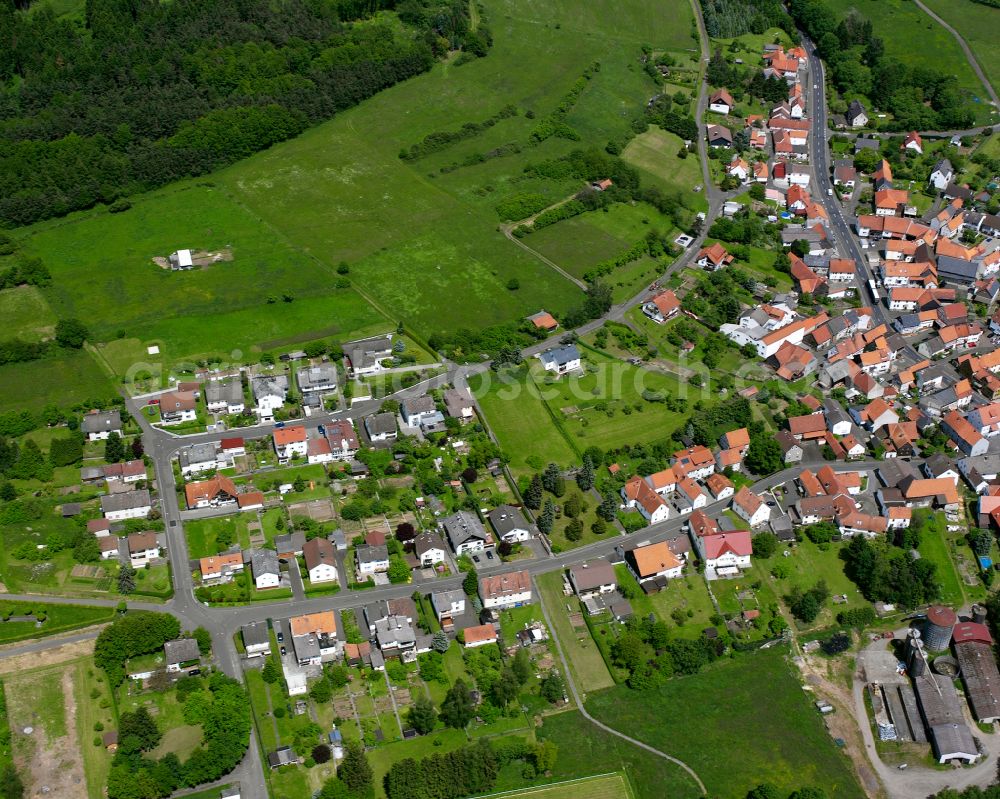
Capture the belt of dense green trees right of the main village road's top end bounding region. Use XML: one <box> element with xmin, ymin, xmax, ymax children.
<box><xmin>788</xmin><ymin>0</ymin><xmax>975</xmax><ymax>130</ymax></box>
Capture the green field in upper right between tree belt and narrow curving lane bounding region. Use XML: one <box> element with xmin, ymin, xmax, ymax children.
<box><xmin>828</xmin><ymin>0</ymin><xmax>984</xmax><ymax>109</ymax></box>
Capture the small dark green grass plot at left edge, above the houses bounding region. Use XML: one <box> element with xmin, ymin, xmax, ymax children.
<box><xmin>0</xmin><ymin>350</ymin><xmax>114</xmax><ymax>412</ymax></box>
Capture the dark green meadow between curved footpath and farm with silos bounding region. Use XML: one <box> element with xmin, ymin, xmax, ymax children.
<box><xmin>587</xmin><ymin>647</ymin><xmax>864</xmax><ymax>799</ymax></box>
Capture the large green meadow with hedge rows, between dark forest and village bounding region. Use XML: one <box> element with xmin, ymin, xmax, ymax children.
<box><xmin>208</xmin><ymin>0</ymin><xmax>691</xmax><ymax>335</ymax></box>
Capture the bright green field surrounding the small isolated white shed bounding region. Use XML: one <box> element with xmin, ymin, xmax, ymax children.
<box><xmin>25</xmin><ymin>183</ymin><xmax>388</xmax><ymax>360</ymax></box>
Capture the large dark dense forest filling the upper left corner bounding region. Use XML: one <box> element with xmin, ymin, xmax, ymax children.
<box><xmin>0</xmin><ymin>0</ymin><xmax>491</xmax><ymax>225</ymax></box>
